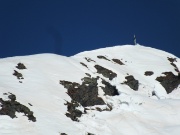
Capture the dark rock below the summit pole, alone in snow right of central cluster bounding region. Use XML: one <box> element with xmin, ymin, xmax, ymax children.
<box><xmin>124</xmin><ymin>75</ymin><xmax>139</xmax><ymax>91</ymax></box>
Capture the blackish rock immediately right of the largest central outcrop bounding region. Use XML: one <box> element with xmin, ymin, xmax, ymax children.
<box><xmin>101</xmin><ymin>80</ymin><xmax>119</xmax><ymax>96</ymax></box>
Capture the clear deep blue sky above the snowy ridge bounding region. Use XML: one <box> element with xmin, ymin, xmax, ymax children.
<box><xmin>0</xmin><ymin>0</ymin><xmax>180</xmax><ymax>58</ymax></box>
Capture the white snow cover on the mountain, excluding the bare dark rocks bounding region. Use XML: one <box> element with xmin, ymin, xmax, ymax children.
<box><xmin>0</xmin><ymin>45</ymin><xmax>180</xmax><ymax>135</ymax></box>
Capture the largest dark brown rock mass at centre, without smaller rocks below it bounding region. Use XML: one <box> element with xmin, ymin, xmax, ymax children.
<box><xmin>60</xmin><ymin>77</ymin><xmax>105</xmax><ymax>107</ymax></box>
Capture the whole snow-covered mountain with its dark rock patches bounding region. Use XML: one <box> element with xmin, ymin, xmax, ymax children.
<box><xmin>0</xmin><ymin>45</ymin><xmax>180</xmax><ymax>135</ymax></box>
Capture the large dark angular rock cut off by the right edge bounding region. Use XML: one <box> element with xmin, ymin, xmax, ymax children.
<box><xmin>156</xmin><ymin>72</ymin><xmax>180</xmax><ymax>94</ymax></box>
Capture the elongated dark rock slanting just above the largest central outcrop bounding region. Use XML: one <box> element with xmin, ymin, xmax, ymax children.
<box><xmin>94</xmin><ymin>65</ymin><xmax>117</xmax><ymax>80</ymax></box>
